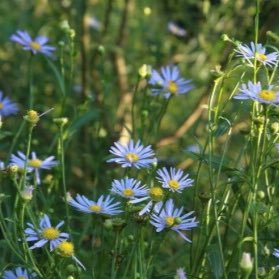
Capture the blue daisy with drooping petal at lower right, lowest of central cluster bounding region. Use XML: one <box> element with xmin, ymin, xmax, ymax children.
<box><xmin>150</xmin><ymin>199</ymin><xmax>198</xmax><ymax>242</ymax></box>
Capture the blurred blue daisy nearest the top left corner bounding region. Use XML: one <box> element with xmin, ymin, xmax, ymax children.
<box><xmin>10</xmin><ymin>30</ymin><xmax>55</xmax><ymax>56</ymax></box>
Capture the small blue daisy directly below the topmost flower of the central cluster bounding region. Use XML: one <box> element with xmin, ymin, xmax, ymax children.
<box><xmin>111</xmin><ymin>177</ymin><xmax>148</xmax><ymax>200</ymax></box>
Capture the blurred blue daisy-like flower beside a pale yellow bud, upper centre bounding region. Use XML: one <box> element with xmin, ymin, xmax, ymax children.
<box><xmin>149</xmin><ymin>66</ymin><xmax>193</xmax><ymax>99</ymax></box>
